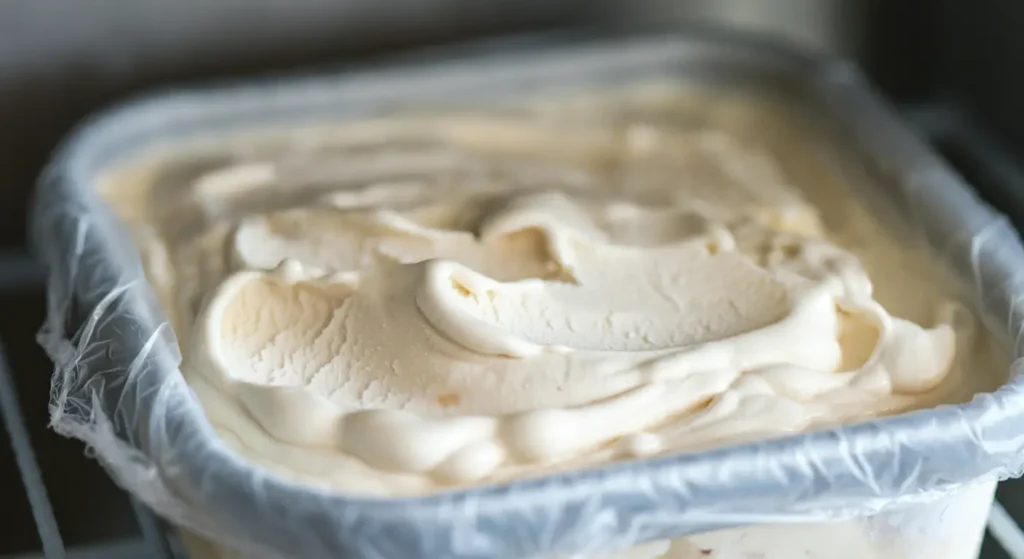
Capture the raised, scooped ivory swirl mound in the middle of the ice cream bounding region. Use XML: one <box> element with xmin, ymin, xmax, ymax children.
<box><xmin>186</xmin><ymin>165</ymin><xmax>964</xmax><ymax>484</ymax></box>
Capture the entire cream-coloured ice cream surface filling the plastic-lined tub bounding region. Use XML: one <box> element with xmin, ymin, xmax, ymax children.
<box><xmin>99</xmin><ymin>89</ymin><xmax>994</xmax><ymax>495</ymax></box>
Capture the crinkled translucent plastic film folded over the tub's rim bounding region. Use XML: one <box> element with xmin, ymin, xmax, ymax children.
<box><xmin>25</xmin><ymin>30</ymin><xmax>1024</xmax><ymax>559</ymax></box>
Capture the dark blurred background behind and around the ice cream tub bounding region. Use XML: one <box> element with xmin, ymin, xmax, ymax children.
<box><xmin>0</xmin><ymin>0</ymin><xmax>1024</xmax><ymax>559</ymax></box>
